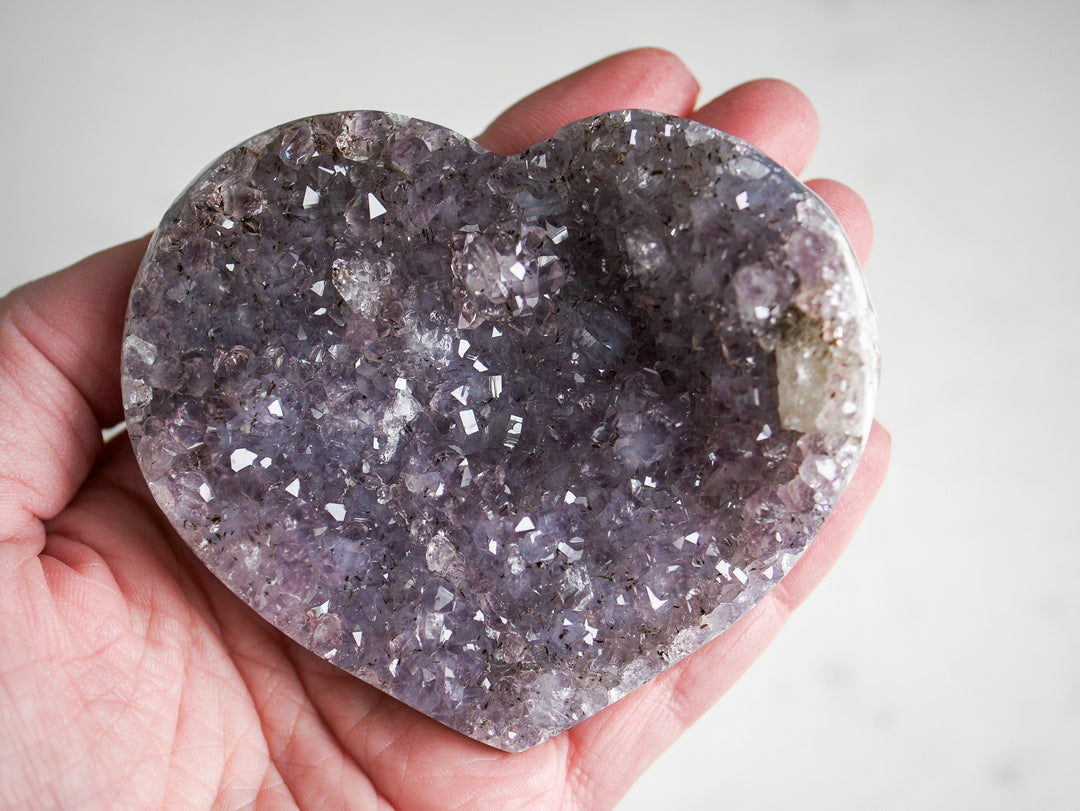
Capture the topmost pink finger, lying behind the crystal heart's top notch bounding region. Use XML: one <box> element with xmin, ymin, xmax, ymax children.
<box><xmin>476</xmin><ymin>48</ymin><xmax>698</xmax><ymax>154</ymax></box>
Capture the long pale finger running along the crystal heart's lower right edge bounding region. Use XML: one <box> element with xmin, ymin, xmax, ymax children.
<box><xmin>567</xmin><ymin>423</ymin><xmax>890</xmax><ymax>808</ymax></box>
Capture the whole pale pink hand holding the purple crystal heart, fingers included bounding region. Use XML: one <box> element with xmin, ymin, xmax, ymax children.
<box><xmin>0</xmin><ymin>50</ymin><xmax>889</xmax><ymax>809</ymax></box>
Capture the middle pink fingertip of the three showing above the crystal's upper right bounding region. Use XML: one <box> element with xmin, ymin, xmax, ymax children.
<box><xmin>690</xmin><ymin>79</ymin><xmax>819</xmax><ymax>175</ymax></box>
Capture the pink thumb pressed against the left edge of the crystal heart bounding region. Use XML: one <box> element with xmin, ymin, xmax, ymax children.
<box><xmin>0</xmin><ymin>238</ymin><xmax>147</xmax><ymax>551</ymax></box>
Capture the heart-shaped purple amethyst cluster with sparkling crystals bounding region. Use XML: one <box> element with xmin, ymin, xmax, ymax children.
<box><xmin>123</xmin><ymin>110</ymin><xmax>878</xmax><ymax>751</ymax></box>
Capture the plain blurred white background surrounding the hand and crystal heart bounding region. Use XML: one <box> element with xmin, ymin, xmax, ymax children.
<box><xmin>0</xmin><ymin>0</ymin><xmax>1080</xmax><ymax>811</ymax></box>
